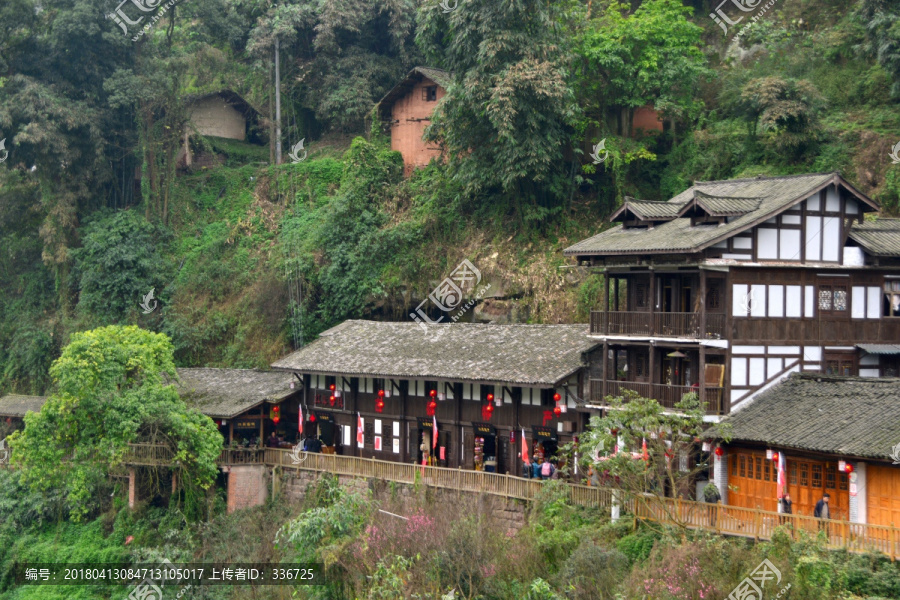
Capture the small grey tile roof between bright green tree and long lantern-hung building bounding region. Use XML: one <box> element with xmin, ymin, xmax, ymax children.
<box><xmin>169</xmin><ymin>368</ymin><xmax>300</xmax><ymax>419</ymax></box>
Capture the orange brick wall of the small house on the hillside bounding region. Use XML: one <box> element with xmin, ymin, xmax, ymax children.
<box><xmin>391</xmin><ymin>79</ymin><xmax>445</xmax><ymax>175</ymax></box>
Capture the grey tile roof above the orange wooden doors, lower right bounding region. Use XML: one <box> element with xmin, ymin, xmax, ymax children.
<box><xmin>723</xmin><ymin>373</ymin><xmax>900</xmax><ymax>459</ymax></box>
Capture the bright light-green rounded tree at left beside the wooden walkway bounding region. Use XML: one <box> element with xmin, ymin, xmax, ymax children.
<box><xmin>9</xmin><ymin>326</ymin><xmax>222</xmax><ymax>520</ymax></box>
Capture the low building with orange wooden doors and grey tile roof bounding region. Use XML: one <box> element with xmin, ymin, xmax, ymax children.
<box><xmin>716</xmin><ymin>373</ymin><xmax>900</xmax><ymax>525</ymax></box>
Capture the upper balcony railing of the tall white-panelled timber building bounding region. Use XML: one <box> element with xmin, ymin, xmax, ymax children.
<box><xmin>591</xmin><ymin>310</ymin><xmax>725</xmax><ymax>340</ymax></box>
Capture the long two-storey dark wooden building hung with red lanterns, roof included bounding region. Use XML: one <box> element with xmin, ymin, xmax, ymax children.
<box><xmin>272</xmin><ymin>320</ymin><xmax>597</xmax><ymax>474</ymax></box>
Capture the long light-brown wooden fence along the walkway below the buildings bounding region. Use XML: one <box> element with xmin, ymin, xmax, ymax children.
<box><xmin>118</xmin><ymin>444</ymin><xmax>900</xmax><ymax>560</ymax></box>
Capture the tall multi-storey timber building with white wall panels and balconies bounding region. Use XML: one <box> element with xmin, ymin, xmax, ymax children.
<box><xmin>565</xmin><ymin>173</ymin><xmax>900</xmax><ymax>421</ymax></box>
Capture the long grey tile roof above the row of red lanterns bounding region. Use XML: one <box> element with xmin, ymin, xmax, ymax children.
<box><xmin>272</xmin><ymin>320</ymin><xmax>597</xmax><ymax>387</ymax></box>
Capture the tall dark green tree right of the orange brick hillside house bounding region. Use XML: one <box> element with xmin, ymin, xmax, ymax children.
<box><xmin>416</xmin><ymin>0</ymin><xmax>577</xmax><ymax>213</ymax></box>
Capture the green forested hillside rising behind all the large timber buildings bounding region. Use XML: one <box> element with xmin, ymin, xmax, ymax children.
<box><xmin>0</xmin><ymin>0</ymin><xmax>900</xmax><ymax>393</ymax></box>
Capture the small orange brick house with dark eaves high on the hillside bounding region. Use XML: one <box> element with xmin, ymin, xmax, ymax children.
<box><xmin>376</xmin><ymin>67</ymin><xmax>450</xmax><ymax>176</ymax></box>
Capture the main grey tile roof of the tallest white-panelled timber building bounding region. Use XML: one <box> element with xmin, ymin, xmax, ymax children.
<box><xmin>564</xmin><ymin>173</ymin><xmax>876</xmax><ymax>255</ymax></box>
